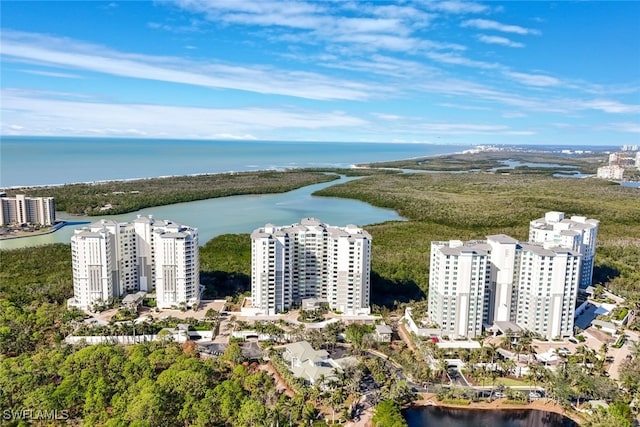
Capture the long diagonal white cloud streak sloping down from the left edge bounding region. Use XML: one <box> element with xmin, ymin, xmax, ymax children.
<box><xmin>2</xmin><ymin>30</ymin><xmax>373</xmax><ymax>100</ymax></box>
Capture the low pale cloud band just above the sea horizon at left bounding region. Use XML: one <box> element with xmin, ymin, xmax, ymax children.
<box><xmin>1</xmin><ymin>89</ymin><xmax>368</xmax><ymax>138</ymax></box>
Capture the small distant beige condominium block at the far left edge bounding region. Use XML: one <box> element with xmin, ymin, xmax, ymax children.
<box><xmin>0</xmin><ymin>193</ymin><xmax>56</xmax><ymax>225</ymax></box>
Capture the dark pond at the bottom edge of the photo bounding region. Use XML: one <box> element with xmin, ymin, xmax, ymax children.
<box><xmin>403</xmin><ymin>407</ymin><xmax>577</xmax><ymax>427</ymax></box>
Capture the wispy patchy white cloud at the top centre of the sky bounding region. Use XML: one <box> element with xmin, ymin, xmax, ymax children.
<box><xmin>166</xmin><ymin>0</ymin><xmax>452</xmax><ymax>51</ymax></box>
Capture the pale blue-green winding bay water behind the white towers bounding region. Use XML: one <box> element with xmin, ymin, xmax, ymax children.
<box><xmin>0</xmin><ymin>177</ymin><xmax>403</xmax><ymax>249</ymax></box>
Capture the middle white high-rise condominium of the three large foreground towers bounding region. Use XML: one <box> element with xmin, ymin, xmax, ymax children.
<box><xmin>251</xmin><ymin>218</ymin><xmax>371</xmax><ymax>315</ymax></box>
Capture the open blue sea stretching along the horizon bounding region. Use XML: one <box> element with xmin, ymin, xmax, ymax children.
<box><xmin>0</xmin><ymin>136</ymin><xmax>471</xmax><ymax>187</ymax></box>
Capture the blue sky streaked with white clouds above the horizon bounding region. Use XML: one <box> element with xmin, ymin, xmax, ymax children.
<box><xmin>0</xmin><ymin>0</ymin><xmax>640</xmax><ymax>146</ymax></box>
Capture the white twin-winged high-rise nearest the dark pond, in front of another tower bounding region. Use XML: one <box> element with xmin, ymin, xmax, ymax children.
<box><xmin>428</xmin><ymin>234</ymin><xmax>581</xmax><ymax>339</ymax></box>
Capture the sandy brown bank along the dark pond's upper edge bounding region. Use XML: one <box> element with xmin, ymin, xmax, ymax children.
<box><xmin>410</xmin><ymin>393</ymin><xmax>586</xmax><ymax>425</ymax></box>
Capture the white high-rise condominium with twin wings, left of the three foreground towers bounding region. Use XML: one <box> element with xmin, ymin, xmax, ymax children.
<box><xmin>68</xmin><ymin>216</ymin><xmax>200</xmax><ymax>310</ymax></box>
